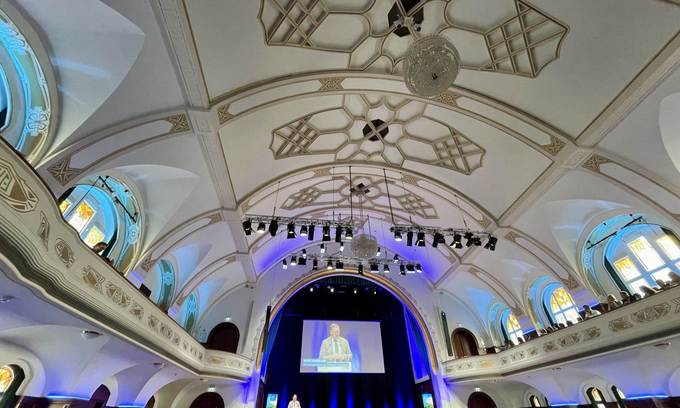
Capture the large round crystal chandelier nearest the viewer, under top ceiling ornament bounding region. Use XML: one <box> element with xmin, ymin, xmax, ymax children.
<box><xmin>404</xmin><ymin>35</ymin><xmax>460</xmax><ymax>97</ymax></box>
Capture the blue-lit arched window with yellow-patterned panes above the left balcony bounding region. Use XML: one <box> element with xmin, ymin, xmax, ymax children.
<box><xmin>59</xmin><ymin>176</ymin><xmax>141</xmax><ymax>272</ymax></box>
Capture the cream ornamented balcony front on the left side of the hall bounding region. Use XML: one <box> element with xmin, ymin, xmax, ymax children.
<box><xmin>0</xmin><ymin>142</ymin><xmax>253</xmax><ymax>381</ymax></box>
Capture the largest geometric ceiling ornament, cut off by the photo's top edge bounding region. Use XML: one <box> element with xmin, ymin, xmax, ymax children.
<box><xmin>258</xmin><ymin>0</ymin><xmax>569</xmax><ymax>78</ymax></box>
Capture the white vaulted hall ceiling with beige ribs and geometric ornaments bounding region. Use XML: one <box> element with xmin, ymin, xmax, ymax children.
<box><xmin>16</xmin><ymin>0</ymin><xmax>680</xmax><ymax>334</ymax></box>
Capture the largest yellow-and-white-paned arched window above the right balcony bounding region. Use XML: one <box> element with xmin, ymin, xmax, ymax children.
<box><xmin>605</xmin><ymin>224</ymin><xmax>680</xmax><ymax>294</ymax></box>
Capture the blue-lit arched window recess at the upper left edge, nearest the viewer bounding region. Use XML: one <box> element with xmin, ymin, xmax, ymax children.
<box><xmin>0</xmin><ymin>10</ymin><xmax>52</xmax><ymax>162</ymax></box>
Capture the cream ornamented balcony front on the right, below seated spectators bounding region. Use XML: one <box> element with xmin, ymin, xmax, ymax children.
<box><xmin>443</xmin><ymin>286</ymin><xmax>680</xmax><ymax>381</ymax></box>
